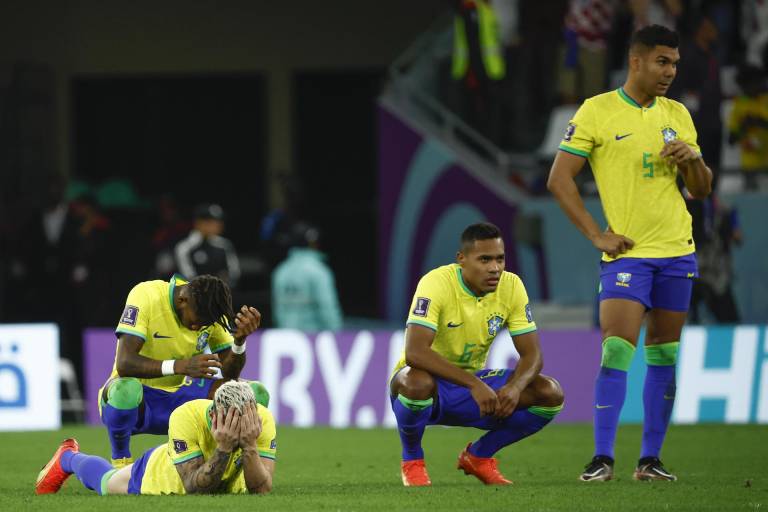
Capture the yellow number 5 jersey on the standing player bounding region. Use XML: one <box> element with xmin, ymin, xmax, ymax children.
<box><xmin>560</xmin><ymin>88</ymin><xmax>701</xmax><ymax>261</ymax></box>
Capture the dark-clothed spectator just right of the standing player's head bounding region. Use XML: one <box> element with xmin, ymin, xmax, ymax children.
<box><xmin>667</xmin><ymin>16</ymin><xmax>723</xmax><ymax>177</ymax></box>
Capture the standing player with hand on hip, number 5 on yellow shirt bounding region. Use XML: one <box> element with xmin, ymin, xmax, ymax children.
<box><xmin>547</xmin><ymin>25</ymin><xmax>712</xmax><ymax>481</ymax></box>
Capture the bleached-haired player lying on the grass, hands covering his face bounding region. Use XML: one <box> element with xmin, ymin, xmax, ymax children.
<box><xmin>35</xmin><ymin>381</ymin><xmax>276</xmax><ymax>495</ymax></box>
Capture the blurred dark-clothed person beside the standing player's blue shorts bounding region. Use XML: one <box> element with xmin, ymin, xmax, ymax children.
<box><xmin>686</xmin><ymin>194</ymin><xmax>743</xmax><ymax>324</ymax></box>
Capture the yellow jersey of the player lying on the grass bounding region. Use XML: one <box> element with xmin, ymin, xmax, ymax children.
<box><xmin>141</xmin><ymin>400</ymin><xmax>277</xmax><ymax>494</ymax></box>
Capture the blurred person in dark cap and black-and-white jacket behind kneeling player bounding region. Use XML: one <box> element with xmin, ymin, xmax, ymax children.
<box><xmin>174</xmin><ymin>203</ymin><xmax>240</xmax><ymax>288</ymax></box>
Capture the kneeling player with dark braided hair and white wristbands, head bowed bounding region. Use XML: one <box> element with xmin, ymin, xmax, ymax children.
<box><xmin>99</xmin><ymin>275</ymin><xmax>268</xmax><ymax>466</ymax></box>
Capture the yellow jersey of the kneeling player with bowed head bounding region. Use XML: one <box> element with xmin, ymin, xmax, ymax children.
<box><xmin>109</xmin><ymin>274</ymin><xmax>233</xmax><ymax>396</ymax></box>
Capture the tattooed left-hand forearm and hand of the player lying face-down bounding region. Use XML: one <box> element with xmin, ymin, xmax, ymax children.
<box><xmin>176</xmin><ymin>407</ymin><xmax>240</xmax><ymax>494</ymax></box>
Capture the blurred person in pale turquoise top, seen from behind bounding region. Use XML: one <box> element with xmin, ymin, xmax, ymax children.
<box><xmin>272</xmin><ymin>222</ymin><xmax>341</xmax><ymax>331</ymax></box>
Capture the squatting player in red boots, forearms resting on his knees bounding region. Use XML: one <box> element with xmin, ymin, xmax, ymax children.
<box><xmin>390</xmin><ymin>223</ymin><xmax>563</xmax><ymax>486</ymax></box>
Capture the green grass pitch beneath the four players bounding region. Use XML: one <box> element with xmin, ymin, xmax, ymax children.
<box><xmin>0</xmin><ymin>425</ymin><xmax>768</xmax><ymax>512</ymax></box>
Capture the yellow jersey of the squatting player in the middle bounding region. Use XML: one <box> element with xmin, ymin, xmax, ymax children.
<box><xmin>393</xmin><ymin>263</ymin><xmax>536</xmax><ymax>375</ymax></box>
